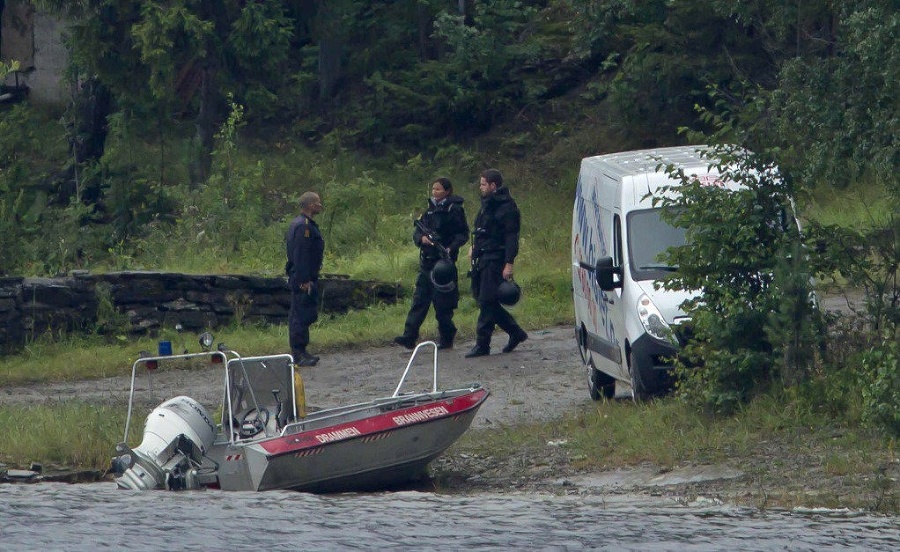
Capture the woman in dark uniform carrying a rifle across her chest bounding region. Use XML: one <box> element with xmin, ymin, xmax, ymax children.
<box><xmin>394</xmin><ymin>178</ymin><xmax>469</xmax><ymax>349</ymax></box>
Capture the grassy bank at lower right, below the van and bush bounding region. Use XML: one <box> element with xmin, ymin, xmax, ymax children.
<box><xmin>451</xmin><ymin>396</ymin><xmax>900</xmax><ymax>514</ymax></box>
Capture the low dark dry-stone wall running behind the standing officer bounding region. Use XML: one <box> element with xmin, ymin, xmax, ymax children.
<box><xmin>0</xmin><ymin>272</ymin><xmax>402</xmax><ymax>352</ymax></box>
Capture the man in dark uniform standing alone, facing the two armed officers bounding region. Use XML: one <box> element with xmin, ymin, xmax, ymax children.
<box><xmin>285</xmin><ymin>192</ymin><xmax>325</xmax><ymax>366</ymax></box>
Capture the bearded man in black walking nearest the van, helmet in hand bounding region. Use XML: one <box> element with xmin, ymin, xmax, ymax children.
<box><xmin>466</xmin><ymin>169</ymin><xmax>528</xmax><ymax>358</ymax></box>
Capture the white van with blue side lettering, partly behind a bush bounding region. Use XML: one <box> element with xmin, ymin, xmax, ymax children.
<box><xmin>572</xmin><ymin>146</ymin><xmax>730</xmax><ymax>400</ymax></box>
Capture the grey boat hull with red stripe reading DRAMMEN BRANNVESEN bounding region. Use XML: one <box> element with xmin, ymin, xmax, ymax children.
<box><xmin>208</xmin><ymin>389</ymin><xmax>489</xmax><ymax>492</ymax></box>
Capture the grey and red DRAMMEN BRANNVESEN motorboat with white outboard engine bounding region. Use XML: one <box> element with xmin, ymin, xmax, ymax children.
<box><xmin>111</xmin><ymin>333</ymin><xmax>489</xmax><ymax>492</ymax></box>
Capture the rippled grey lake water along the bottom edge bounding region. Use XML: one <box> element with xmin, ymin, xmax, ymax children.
<box><xmin>0</xmin><ymin>483</ymin><xmax>900</xmax><ymax>551</ymax></box>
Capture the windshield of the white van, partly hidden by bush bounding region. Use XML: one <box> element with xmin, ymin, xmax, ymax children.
<box><xmin>627</xmin><ymin>209</ymin><xmax>687</xmax><ymax>280</ymax></box>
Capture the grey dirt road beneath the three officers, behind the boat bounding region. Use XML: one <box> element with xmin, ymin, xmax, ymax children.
<box><xmin>0</xmin><ymin>327</ymin><xmax>590</xmax><ymax>427</ymax></box>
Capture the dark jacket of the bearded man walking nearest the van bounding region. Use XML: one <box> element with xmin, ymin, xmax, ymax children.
<box><xmin>472</xmin><ymin>187</ymin><xmax>521</xmax><ymax>263</ymax></box>
